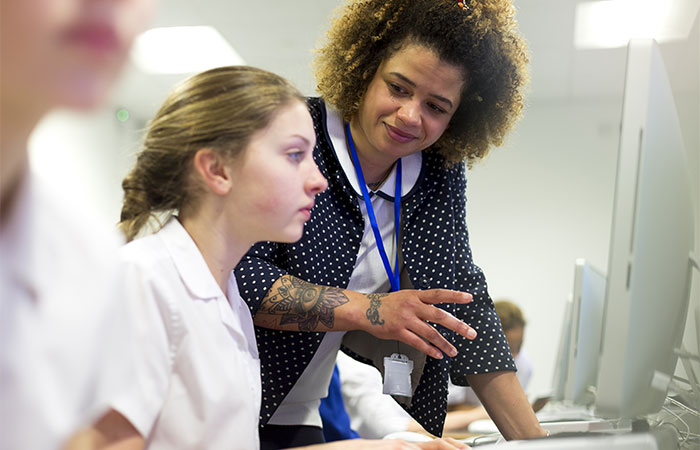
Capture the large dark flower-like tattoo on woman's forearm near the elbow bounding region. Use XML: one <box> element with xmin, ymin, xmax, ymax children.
<box><xmin>260</xmin><ymin>275</ymin><xmax>350</xmax><ymax>331</ymax></box>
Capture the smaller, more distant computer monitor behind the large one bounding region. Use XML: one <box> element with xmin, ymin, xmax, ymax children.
<box><xmin>564</xmin><ymin>258</ymin><xmax>606</xmax><ymax>406</ymax></box>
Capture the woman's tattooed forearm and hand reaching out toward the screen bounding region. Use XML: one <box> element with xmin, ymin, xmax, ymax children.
<box><xmin>254</xmin><ymin>275</ymin><xmax>476</xmax><ymax>359</ymax></box>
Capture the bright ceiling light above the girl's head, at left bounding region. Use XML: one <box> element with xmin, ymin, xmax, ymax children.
<box><xmin>131</xmin><ymin>26</ymin><xmax>245</xmax><ymax>73</ymax></box>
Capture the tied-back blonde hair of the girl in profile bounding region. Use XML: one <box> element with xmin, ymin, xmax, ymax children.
<box><xmin>119</xmin><ymin>66</ymin><xmax>305</xmax><ymax>241</ymax></box>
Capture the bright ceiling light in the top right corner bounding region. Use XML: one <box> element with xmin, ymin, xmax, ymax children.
<box><xmin>574</xmin><ymin>0</ymin><xmax>700</xmax><ymax>48</ymax></box>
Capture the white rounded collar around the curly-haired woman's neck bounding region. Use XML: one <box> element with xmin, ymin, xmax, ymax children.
<box><xmin>324</xmin><ymin>103</ymin><xmax>423</xmax><ymax>201</ymax></box>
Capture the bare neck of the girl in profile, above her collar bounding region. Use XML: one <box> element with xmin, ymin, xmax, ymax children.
<box><xmin>180</xmin><ymin>210</ymin><xmax>253</xmax><ymax>296</ymax></box>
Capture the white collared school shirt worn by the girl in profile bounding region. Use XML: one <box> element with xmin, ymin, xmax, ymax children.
<box><xmin>115</xmin><ymin>218</ymin><xmax>262</xmax><ymax>450</ymax></box>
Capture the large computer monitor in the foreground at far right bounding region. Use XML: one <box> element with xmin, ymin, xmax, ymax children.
<box><xmin>595</xmin><ymin>40</ymin><xmax>695</xmax><ymax>419</ymax></box>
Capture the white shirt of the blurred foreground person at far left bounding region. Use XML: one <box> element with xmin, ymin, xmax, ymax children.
<box><xmin>0</xmin><ymin>172</ymin><xmax>133</xmax><ymax>449</ymax></box>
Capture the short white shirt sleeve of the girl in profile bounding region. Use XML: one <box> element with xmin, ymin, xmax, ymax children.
<box><xmin>112</xmin><ymin>262</ymin><xmax>184</xmax><ymax>437</ymax></box>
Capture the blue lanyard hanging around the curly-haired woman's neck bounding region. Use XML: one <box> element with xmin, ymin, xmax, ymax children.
<box><xmin>345</xmin><ymin>123</ymin><xmax>401</xmax><ymax>292</ymax></box>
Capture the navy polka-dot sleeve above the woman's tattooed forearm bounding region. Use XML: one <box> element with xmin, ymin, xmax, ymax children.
<box><xmin>234</xmin><ymin>242</ymin><xmax>287</xmax><ymax>316</ymax></box>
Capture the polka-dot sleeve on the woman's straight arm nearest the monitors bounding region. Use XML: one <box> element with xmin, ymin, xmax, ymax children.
<box><xmin>450</xmin><ymin>164</ymin><xmax>516</xmax><ymax>386</ymax></box>
